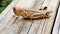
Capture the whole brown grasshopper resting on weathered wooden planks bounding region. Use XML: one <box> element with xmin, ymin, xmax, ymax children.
<box><xmin>13</xmin><ymin>7</ymin><xmax>51</xmax><ymax>20</ymax></box>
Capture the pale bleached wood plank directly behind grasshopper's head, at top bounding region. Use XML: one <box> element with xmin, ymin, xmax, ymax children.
<box><xmin>15</xmin><ymin>0</ymin><xmax>37</xmax><ymax>8</ymax></box>
